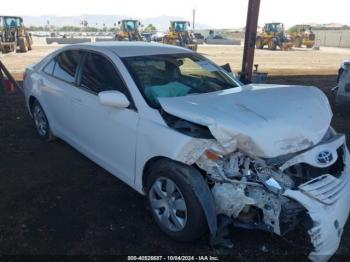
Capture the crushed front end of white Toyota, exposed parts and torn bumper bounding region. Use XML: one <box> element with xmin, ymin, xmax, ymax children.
<box><xmin>196</xmin><ymin>130</ymin><xmax>350</xmax><ymax>261</ymax></box>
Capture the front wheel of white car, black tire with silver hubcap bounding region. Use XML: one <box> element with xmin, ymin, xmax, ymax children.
<box><xmin>146</xmin><ymin>160</ymin><xmax>207</xmax><ymax>242</ymax></box>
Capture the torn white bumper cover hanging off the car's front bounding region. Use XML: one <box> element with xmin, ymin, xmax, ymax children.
<box><xmin>283</xmin><ymin>145</ymin><xmax>350</xmax><ymax>261</ymax></box>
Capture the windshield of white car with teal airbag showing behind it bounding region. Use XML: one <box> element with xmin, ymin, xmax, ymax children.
<box><xmin>123</xmin><ymin>54</ymin><xmax>239</xmax><ymax>108</ymax></box>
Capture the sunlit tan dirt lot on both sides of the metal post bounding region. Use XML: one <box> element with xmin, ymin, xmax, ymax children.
<box><xmin>198</xmin><ymin>45</ymin><xmax>350</xmax><ymax>75</ymax></box>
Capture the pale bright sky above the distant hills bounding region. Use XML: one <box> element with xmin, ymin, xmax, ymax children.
<box><xmin>0</xmin><ymin>0</ymin><xmax>350</xmax><ymax>28</ymax></box>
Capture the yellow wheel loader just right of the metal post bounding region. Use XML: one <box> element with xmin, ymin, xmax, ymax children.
<box><xmin>255</xmin><ymin>23</ymin><xmax>293</xmax><ymax>50</ymax></box>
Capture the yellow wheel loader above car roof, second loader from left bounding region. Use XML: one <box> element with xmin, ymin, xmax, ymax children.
<box><xmin>115</xmin><ymin>19</ymin><xmax>143</xmax><ymax>41</ymax></box>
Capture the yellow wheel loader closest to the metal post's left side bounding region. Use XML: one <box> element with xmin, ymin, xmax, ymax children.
<box><xmin>163</xmin><ymin>21</ymin><xmax>198</xmax><ymax>51</ymax></box>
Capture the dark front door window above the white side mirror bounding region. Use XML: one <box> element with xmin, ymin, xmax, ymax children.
<box><xmin>80</xmin><ymin>53</ymin><xmax>125</xmax><ymax>94</ymax></box>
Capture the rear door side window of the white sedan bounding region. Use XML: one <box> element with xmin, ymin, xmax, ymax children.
<box><xmin>53</xmin><ymin>50</ymin><xmax>81</xmax><ymax>83</ymax></box>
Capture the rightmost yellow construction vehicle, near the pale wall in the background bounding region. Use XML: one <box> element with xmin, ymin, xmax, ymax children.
<box><xmin>289</xmin><ymin>25</ymin><xmax>315</xmax><ymax>48</ymax></box>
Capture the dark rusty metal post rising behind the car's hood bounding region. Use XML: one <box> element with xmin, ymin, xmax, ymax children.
<box><xmin>240</xmin><ymin>0</ymin><xmax>260</xmax><ymax>82</ymax></box>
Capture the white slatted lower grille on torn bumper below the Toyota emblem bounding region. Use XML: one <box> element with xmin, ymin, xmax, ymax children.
<box><xmin>299</xmin><ymin>174</ymin><xmax>350</xmax><ymax>205</ymax></box>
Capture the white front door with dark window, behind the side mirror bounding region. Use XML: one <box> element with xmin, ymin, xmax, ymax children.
<box><xmin>72</xmin><ymin>49</ymin><xmax>139</xmax><ymax>184</ymax></box>
